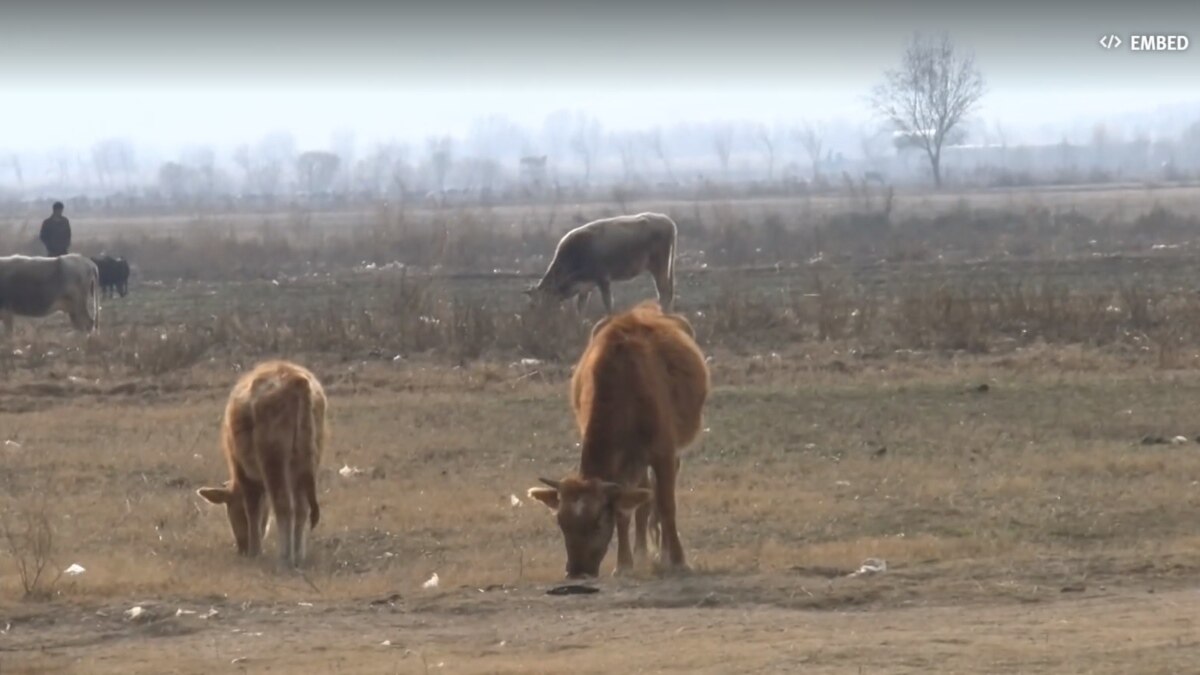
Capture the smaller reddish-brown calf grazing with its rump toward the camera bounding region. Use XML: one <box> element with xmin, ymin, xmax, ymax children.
<box><xmin>197</xmin><ymin>360</ymin><xmax>325</xmax><ymax>567</ymax></box>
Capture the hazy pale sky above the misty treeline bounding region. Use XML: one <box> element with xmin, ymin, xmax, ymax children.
<box><xmin>0</xmin><ymin>0</ymin><xmax>1200</xmax><ymax>151</ymax></box>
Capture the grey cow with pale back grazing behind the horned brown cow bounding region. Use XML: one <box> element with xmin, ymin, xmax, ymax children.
<box><xmin>526</xmin><ymin>213</ymin><xmax>677</xmax><ymax>315</ymax></box>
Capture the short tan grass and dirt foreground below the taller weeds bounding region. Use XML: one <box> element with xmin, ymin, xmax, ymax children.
<box><xmin>0</xmin><ymin>348</ymin><xmax>1200</xmax><ymax>673</ymax></box>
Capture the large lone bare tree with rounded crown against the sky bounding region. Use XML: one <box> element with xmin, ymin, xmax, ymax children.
<box><xmin>871</xmin><ymin>32</ymin><xmax>984</xmax><ymax>187</ymax></box>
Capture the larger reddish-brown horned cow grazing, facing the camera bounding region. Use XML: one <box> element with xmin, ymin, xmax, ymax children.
<box><xmin>528</xmin><ymin>301</ymin><xmax>709</xmax><ymax>578</ymax></box>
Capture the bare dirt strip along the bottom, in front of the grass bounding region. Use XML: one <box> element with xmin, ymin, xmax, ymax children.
<box><xmin>0</xmin><ymin>571</ymin><xmax>1200</xmax><ymax>674</ymax></box>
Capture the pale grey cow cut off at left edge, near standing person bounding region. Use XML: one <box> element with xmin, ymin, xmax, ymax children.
<box><xmin>0</xmin><ymin>253</ymin><xmax>100</xmax><ymax>335</ymax></box>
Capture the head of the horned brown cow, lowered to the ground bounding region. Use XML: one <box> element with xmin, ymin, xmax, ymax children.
<box><xmin>528</xmin><ymin>477</ymin><xmax>654</xmax><ymax>579</ymax></box>
